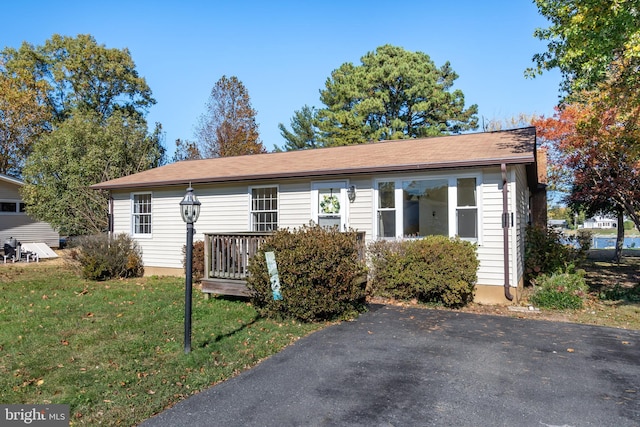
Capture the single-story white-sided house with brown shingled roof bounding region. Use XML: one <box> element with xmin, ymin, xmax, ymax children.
<box><xmin>93</xmin><ymin>127</ymin><xmax>547</xmax><ymax>302</ymax></box>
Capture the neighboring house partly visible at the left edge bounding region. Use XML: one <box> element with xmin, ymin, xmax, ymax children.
<box><xmin>0</xmin><ymin>174</ymin><xmax>60</xmax><ymax>248</ymax></box>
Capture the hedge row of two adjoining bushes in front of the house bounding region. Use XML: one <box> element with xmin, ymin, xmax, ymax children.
<box><xmin>248</xmin><ymin>226</ymin><xmax>479</xmax><ymax>321</ymax></box>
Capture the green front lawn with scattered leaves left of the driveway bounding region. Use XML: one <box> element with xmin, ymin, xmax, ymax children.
<box><xmin>0</xmin><ymin>262</ymin><xmax>321</xmax><ymax>425</ymax></box>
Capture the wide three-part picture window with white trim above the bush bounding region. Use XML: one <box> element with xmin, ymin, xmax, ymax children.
<box><xmin>375</xmin><ymin>175</ymin><xmax>479</xmax><ymax>241</ymax></box>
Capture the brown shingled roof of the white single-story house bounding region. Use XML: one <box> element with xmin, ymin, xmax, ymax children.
<box><xmin>92</xmin><ymin>127</ymin><xmax>536</xmax><ymax>189</ymax></box>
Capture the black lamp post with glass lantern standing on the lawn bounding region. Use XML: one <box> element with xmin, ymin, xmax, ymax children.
<box><xmin>180</xmin><ymin>186</ymin><xmax>200</xmax><ymax>354</ymax></box>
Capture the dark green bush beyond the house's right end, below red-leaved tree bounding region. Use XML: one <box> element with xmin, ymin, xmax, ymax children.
<box><xmin>524</xmin><ymin>226</ymin><xmax>591</xmax><ymax>284</ymax></box>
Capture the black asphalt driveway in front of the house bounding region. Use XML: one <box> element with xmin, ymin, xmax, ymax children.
<box><xmin>142</xmin><ymin>306</ymin><xmax>640</xmax><ymax>427</ymax></box>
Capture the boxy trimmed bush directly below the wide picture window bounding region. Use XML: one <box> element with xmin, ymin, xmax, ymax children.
<box><xmin>369</xmin><ymin>236</ymin><xmax>479</xmax><ymax>307</ymax></box>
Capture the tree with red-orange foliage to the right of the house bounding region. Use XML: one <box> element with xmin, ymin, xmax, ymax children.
<box><xmin>534</xmin><ymin>103</ymin><xmax>640</xmax><ymax>258</ymax></box>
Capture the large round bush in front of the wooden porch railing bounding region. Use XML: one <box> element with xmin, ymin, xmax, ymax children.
<box><xmin>247</xmin><ymin>226</ymin><xmax>366</xmax><ymax>322</ymax></box>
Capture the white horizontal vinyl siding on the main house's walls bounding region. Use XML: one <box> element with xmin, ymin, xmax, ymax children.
<box><xmin>112</xmin><ymin>166</ymin><xmax>527</xmax><ymax>286</ymax></box>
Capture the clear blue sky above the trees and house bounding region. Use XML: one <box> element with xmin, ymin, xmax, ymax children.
<box><xmin>0</xmin><ymin>0</ymin><xmax>560</xmax><ymax>153</ymax></box>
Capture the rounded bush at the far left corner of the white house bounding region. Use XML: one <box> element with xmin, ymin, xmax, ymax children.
<box><xmin>69</xmin><ymin>233</ymin><xmax>144</xmax><ymax>280</ymax></box>
